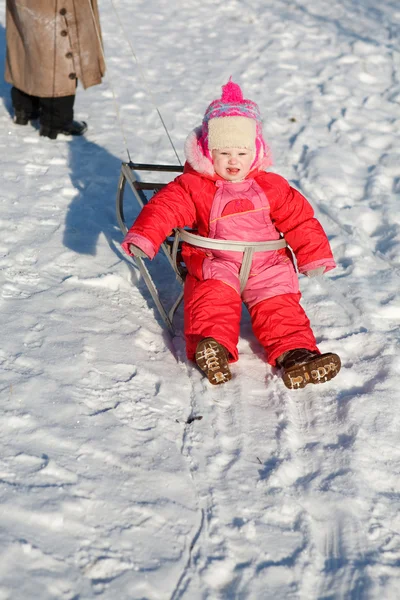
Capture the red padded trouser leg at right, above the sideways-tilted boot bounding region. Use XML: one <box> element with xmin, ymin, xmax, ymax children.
<box><xmin>249</xmin><ymin>293</ymin><xmax>319</xmax><ymax>366</ymax></box>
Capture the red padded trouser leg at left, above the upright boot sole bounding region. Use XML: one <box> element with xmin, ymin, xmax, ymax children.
<box><xmin>184</xmin><ymin>275</ymin><xmax>242</xmax><ymax>361</ymax></box>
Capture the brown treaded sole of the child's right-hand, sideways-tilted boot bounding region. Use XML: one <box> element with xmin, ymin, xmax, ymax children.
<box><xmin>282</xmin><ymin>352</ymin><xmax>341</xmax><ymax>390</ymax></box>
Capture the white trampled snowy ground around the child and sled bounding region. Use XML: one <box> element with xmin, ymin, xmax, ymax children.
<box><xmin>0</xmin><ymin>0</ymin><xmax>400</xmax><ymax>600</ymax></box>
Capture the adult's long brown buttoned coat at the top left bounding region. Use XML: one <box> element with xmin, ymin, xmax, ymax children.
<box><xmin>5</xmin><ymin>0</ymin><xmax>105</xmax><ymax>98</ymax></box>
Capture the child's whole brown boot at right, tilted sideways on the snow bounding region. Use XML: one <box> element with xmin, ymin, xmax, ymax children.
<box><xmin>277</xmin><ymin>348</ymin><xmax>341</xmax><ymax>390</ymax></box>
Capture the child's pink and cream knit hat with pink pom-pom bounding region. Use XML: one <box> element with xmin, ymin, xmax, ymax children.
<box><xmin>199</xmin><ymin>78</ymin><xmax>266</xmax><ymax>162</ymax></box>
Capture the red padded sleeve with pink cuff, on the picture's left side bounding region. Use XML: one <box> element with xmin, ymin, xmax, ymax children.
<box><xmin>121</xmin><ymin>175</ymin><xmax>196</xmax><ymax>258</ymax></box>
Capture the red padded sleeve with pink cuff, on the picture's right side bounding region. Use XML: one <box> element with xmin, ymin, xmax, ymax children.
<box><xmin>269</xmin><ymin>175</ymin><xmax>336</xmax><ymax>273</ymax></box>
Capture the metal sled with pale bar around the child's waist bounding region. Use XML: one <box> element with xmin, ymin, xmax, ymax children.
<box><xmin>116</xmin><ymin>162</ymin><xmax>287</xmax><ymax>335</ymax></box>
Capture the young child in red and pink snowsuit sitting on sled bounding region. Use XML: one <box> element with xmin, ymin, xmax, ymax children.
<box><xmin>122</xmin><ymin>80</ymin><xmax>340</xmax><ymax>389</ymax></box>
